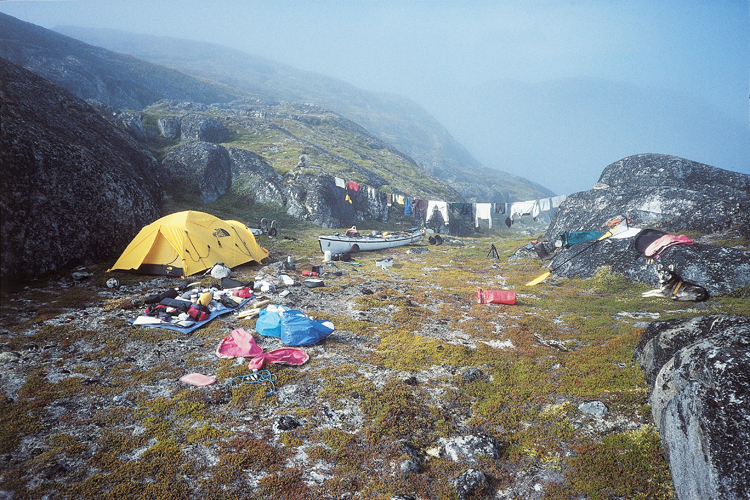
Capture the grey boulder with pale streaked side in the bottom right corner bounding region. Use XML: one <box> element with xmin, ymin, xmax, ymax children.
<box><xmin>635</xmin><ymin>315</ymin><xmax>750</xmax><ymax>500</ymax></box>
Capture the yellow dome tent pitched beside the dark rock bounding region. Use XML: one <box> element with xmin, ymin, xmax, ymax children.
<box><xmin>108</xmin><ymin>210</ymin><xmax>268</xmax><ymax>277</ymax></box>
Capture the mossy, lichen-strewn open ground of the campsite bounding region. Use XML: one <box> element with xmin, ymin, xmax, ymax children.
<box><xmin>0</xmin><ymin>196</ymin><xmax>750</xmax><ymax>499</ymax></box>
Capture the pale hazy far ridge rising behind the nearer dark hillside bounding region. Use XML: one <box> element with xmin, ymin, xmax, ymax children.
<box><xmin>44</xmin><ymin>18</ymin><xmax>553</xmax><ymax>201</ymax></box>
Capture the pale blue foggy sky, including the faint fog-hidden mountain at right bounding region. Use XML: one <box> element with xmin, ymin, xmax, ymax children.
<box><xmin>0</xmin><ymin>0</ymin><xmax>750</xmax><ymax>193</ymax></box>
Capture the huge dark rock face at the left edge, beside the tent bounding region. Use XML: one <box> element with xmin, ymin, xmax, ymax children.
<box><xmin>0</xmin><ymin>58</ymin><xmax>162</xmax><ymax>276</ymax></box>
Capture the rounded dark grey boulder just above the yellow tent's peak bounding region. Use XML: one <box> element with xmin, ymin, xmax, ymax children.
<box><xmin>162</xmin><ymin>142</ymin><xmax>232</xmax><ymax>203</ymax></box>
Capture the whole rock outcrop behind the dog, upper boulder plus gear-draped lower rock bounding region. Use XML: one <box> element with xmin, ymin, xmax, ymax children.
<box><xmin>544</xmin><ymin>155</ymin><xmax>750</xmax><ymax>295</ymax></box>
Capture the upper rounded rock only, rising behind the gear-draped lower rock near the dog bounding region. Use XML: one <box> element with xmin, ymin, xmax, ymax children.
<box><xmin>545</xmin><ymin>154</ymin><xmax>750</xmax><ymax>241</ymax></box>
